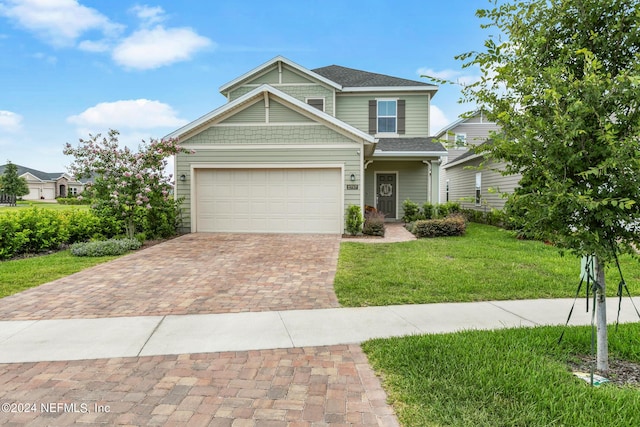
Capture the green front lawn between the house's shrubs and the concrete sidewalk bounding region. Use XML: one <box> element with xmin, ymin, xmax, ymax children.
<box><xmin>335</xmin><ymin>223</ymin><xmax>640</xmax><ymax>307</ymax></box>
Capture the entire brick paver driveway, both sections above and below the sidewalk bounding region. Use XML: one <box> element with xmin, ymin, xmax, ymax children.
<box><xmin>0</xmin><ymin>234</ymin><xmax>398</xmax><ymax>427</ymax></box>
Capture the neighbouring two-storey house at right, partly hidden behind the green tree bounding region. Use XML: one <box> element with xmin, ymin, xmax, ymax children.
<box><xmin>434</xmin><ymin>110</ymin><xmax>520</xmax><ymax>210</ymax></box>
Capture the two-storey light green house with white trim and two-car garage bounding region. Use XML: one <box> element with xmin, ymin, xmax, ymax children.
<box><xmin>167</xmin><ymin>56</ymin><xmax>446</xmax><ymax>233</ymax></box>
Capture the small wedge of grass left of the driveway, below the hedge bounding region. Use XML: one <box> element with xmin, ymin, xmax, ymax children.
<box><xmin>0</xmin><ymin>250</ymin><xmax>118</xmax><ymax>298</ymax></box>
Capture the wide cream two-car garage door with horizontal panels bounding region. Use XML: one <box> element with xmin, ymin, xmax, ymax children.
<box><xmin>196</xmin><ymin>168</ymin><xmax>343</xmax><ymax>233</ymax></box>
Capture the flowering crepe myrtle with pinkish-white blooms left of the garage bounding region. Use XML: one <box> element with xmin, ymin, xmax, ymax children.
<box><xmin>63</xmin><ymin>129</ymin><xmax>196</xmax><ymax>238</ymax></box>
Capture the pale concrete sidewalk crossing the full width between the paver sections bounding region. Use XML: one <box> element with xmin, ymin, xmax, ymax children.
<box><xmin>0</xmin><ymin>297</ymin><xmax>640</xmax><ymax>363</ymax></box>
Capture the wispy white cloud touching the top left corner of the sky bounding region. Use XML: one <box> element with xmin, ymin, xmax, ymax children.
<box><xmin>0</xmin><ymin>0</ymin><xmax>123</xmax><ymax>47</ymax></box>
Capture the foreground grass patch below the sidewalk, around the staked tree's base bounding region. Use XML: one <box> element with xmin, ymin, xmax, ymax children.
<box><xmin>362</xmin><ymin>323</ymin><xmax>640</xmax><ymax>427</ymax></box>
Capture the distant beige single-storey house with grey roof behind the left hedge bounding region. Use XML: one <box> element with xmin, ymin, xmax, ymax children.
<box><xmin>0</xmin><ymin>165</ymin><xmax>87</xmax><ymax>200</ymax></box>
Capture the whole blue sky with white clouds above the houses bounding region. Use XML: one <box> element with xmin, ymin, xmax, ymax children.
<box><xmin>0</xmin><ymin>0</ymin><xmax>489</xmax><ymax>172</ymax></box>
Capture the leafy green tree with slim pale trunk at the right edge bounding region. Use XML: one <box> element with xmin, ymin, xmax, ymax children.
<box><xmin>457</xmin><ymin>0</ymin><xmax>640</xmax><ymax>372</ymax></box>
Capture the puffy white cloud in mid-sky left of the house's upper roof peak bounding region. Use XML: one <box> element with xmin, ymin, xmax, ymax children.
<box><xmin>113</xmin><ymin>25</ymin><xmax>215</xmax><ymax>70</ymax></box>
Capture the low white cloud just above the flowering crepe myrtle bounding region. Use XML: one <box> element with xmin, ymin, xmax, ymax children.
<box><xmin>67</xmin><ymin>99</ymin><xmax>188</xmax><ymax>133</ymax></box>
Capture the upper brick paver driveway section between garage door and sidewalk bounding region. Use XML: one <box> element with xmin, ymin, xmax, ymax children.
<box><xmin>0</xmin><ymin>233</ymin><xmax>340</xmax><ymax>320</ymax></box>
